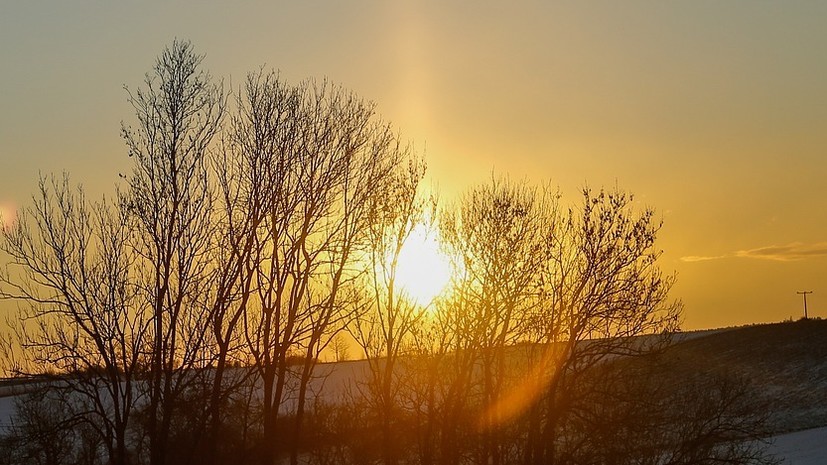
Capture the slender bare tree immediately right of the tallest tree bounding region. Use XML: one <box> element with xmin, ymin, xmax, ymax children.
<box><xmin>188</xmin><ymin>68</ymin><xmax>295</xmax><ymax>463</ymax></box>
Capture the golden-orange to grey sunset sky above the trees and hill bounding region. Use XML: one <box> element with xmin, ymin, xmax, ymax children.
<box><xmin>0</xmin><ymin>0</ymin><xmax>827</xmax><ymax>329</ymax></box>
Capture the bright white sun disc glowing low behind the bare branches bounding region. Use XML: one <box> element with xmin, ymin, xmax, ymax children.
<box><xmin>396</xmin><ymin>224</ymin><xmax>451</xmax><ymax>307</ymax></box>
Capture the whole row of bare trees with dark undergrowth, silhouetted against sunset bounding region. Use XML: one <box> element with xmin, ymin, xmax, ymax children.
<box><xmin>0</xmin><ymin>42</ymin><xmax>766</xmax><ymax>465</ymax></box>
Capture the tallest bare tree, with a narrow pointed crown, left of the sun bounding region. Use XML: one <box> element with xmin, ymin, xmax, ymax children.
<box><xmin>121</xmin><ymin>41</ymin><xmax>225</xmax><ymax>465</ymax></box>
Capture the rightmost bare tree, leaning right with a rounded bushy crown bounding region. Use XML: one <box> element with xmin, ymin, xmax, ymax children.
<box><xmin>525</xmin><ymin>189</ymin><xmax>682</xmax><ymax>463</ymax></box>
